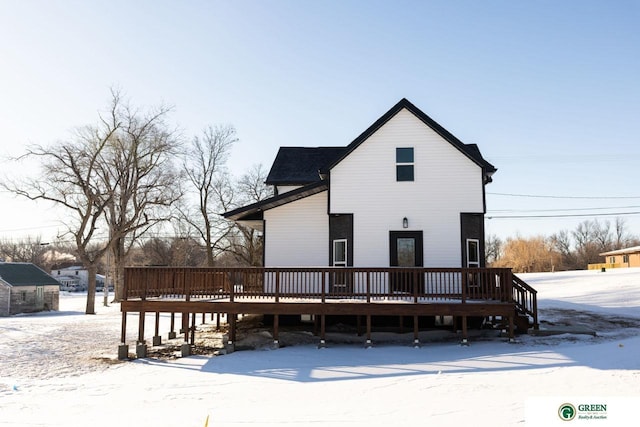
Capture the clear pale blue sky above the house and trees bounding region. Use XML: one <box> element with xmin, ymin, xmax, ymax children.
<box><xmin>0</xmin><ymin>0</ymin><xmax>640</xmax><ymax>244</ymax></box>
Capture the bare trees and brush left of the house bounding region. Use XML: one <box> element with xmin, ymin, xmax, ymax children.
<box><xmin>0</xmin><ymin>90</ymin><xmax>271</xmax><ymax>314</ymax></box>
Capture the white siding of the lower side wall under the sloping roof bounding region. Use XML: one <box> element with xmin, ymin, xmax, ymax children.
<box><xmin>264</xmin><ymin>191</ymin><xmax>329</xmax><ymax>267</ymax></box>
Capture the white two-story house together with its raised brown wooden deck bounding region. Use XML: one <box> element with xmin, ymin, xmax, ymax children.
<box><xmin>119</xmin><ymin>99</ymin><xmax>538</xmax><ymax>354</ymax></box>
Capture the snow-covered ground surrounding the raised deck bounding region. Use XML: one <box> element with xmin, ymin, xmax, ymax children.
<box><xmin>0</xmin><ymin>269</ymin><xmax>640</xmax><ymax>427</ymax></box>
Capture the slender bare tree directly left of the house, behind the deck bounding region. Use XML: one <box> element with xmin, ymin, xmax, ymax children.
<box><xmin>180</xmin><ymin>126</ymin><xmax>238</xmax><ymax>266</ymax></box>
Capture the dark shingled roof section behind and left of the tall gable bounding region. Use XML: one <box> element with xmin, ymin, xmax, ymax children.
<box><xmin>266</xmin><ymin>147</ymin><xmax>347</xmax><ymax>185</ymax></box>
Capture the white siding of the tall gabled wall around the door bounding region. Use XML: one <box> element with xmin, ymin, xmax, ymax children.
<box><xmin>332</xmin><ymin>109</ymin><xmax>483</xmax><ymax>267</ymax></box>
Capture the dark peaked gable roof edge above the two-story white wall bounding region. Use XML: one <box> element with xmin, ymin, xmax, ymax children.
<box><xmin>321</xmin><ymin>98</ymin><xmax>497</xmax><ymax>180</ymax></box>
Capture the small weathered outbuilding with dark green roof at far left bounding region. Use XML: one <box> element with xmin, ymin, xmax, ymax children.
<box><xmin>0</xmin><ymin>262</ymin><xmax>60</xmax><ymax>316</ymax></box>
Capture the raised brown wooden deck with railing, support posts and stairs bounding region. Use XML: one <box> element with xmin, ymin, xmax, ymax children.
<box><xmin>121</xmin><ymin>267</ymin><xmax>538</xmax><ymax>358</ymax></box>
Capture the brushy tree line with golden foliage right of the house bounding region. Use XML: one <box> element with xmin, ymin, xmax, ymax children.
<box><xmin>485</xmin><ymin>218</ymin><xmax>640</xmax><ymax>273</ymax></box>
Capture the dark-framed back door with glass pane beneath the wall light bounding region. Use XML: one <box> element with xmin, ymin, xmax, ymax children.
<box><xmin>389</xmin><ymin>231</ymin><xmax>423</xmax><ymax>294</ymax></box>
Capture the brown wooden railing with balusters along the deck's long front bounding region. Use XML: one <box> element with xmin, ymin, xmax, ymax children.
<box><xmin>124</xmin><ymin>267</ymin><xmax>514</xmax><ymax>303</ymax></box>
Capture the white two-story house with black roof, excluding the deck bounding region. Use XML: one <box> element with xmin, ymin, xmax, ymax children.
<box><xmin>224</xmin><ymin>99</ymin><xmax>496</xmax><ymax>268</ymax></box>
